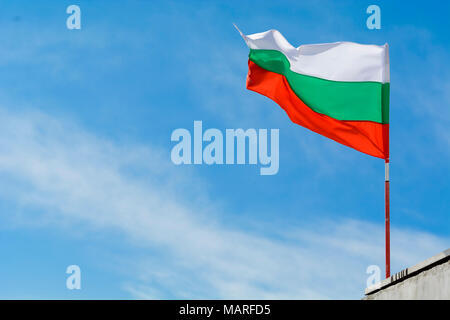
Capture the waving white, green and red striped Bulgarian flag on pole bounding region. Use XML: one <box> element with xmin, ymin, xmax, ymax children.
<box><xmin>238</xmin><ymin>29</ymin><xmax>390</xmax><ymax>159</ymax></box>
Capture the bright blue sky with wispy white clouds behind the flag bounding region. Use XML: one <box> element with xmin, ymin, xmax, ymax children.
<box><xmin>0</xmin><ymin>0</ymin><xmax>450</xmax><ymax>299</ymax></box>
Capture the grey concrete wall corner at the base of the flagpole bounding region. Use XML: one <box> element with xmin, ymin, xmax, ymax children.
<box><xmin>364</xmin><ymin>249</ymin><xmax>450</xmax><ymax>300</ymax></box>
